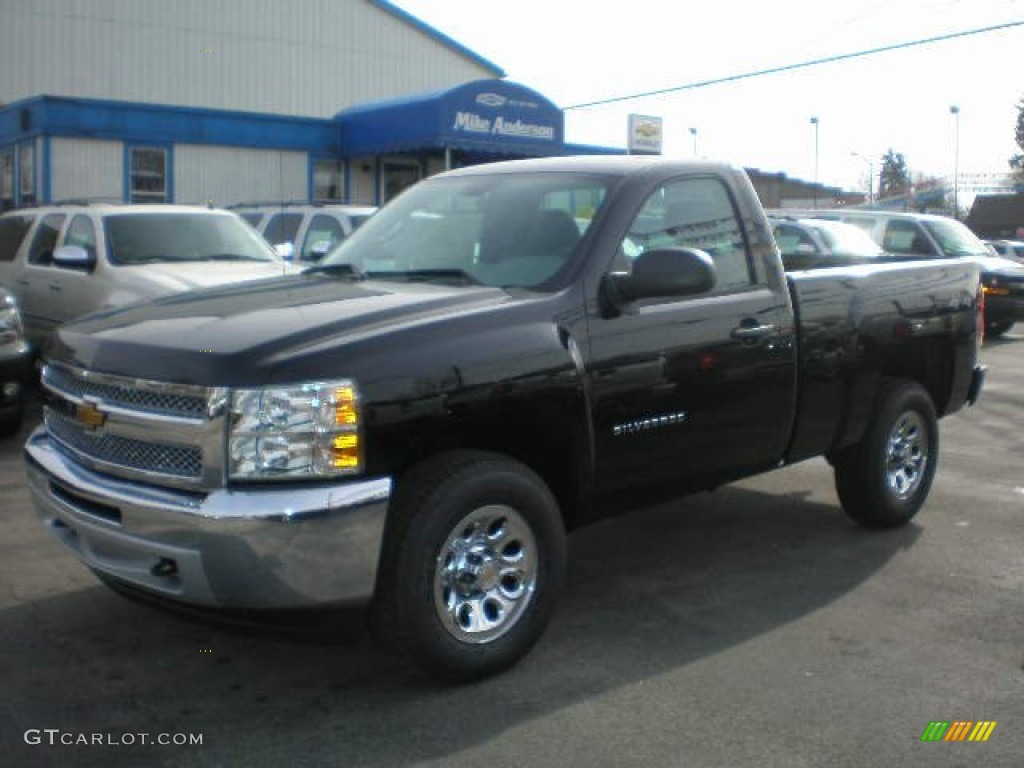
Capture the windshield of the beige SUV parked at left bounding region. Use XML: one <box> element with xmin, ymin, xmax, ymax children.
<box><xmin>103</xmin><ymin>212</ymin><xmax>279</xmax><ymax>266</ymax></box>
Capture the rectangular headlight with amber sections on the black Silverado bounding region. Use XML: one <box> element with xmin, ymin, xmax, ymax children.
<box><xmin>228</xmin><ymin>379</ymin><xmax>362</xmax><ymax>480</ymax></box>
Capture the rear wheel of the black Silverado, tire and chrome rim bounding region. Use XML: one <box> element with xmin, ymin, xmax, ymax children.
<box><xmin>834</xmin><ymin>380</ymin><xmax>939</xmax><ymax>528</ymax></box>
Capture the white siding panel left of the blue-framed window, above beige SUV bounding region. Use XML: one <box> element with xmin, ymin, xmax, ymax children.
<box><xmin>49</xmin><ymin>138</ymin><xmax>124</xmax><ymax>201</ymax></box>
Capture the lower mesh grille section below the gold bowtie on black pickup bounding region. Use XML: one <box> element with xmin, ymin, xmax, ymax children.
<box><xmin>45</xmin><ymin>409</ymin><xmax>203</xmax><ymax>478</ymax></box>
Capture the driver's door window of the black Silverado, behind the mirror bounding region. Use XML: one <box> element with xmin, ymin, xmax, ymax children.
<box><xmin>614</xmin><ymin>178</ymin><xmax>754</xmax><ymax>293</ymax></box>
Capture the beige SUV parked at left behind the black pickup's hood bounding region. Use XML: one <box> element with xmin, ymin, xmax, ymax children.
<box><xmin>0</xmin><ymin>204</ymin><xmax>295</xmax><ymax>349</ymax></box>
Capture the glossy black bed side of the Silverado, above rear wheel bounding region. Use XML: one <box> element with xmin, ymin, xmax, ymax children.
<box><xmin>786</xmin><ymin>259</ymin><xmax>978</xmax><ymax>461</ymax></box>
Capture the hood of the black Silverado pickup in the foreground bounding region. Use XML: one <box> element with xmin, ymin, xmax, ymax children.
<box><xmin>44</xmin><ymin>274</ymin><xmax>512</xmax><ymax>386</ymax></box>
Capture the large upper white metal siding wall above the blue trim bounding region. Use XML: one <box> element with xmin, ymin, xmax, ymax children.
<box><xmin>0</xmin><ymin>0</ymin><xmax>494</xmax><ymax>117</ymax></box>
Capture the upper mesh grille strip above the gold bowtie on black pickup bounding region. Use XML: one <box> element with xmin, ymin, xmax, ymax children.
<box><xmin>43</xmin><ymin>366</ymin><xmax>207</xmax><ymax>419</ymax></box>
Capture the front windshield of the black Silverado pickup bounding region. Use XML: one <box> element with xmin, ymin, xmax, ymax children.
<box><xmin>322</xmin><ymin>173</ymin><xmax>610</xmax><ymax>290</ymax></box>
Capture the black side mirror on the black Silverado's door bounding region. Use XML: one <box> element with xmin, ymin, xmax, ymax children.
<box><xmin>604</xmin><ymin>248</ymin><xmax>716</xmax><ymax>307</ymax></box>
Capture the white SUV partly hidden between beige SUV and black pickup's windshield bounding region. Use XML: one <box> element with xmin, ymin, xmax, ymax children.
<box><xmin>230</xmin><ymin>203</ymin><xmax>377</xmax><ymax>263</ymax></box>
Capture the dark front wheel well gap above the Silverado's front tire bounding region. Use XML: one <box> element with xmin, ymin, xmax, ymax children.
<box><xmin>399</xmin><ymin>403</ymin><xmax>590</xmax><ymax>528</ymax></box>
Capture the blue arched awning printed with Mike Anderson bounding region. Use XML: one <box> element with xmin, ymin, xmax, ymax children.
<box><xmin>335</xmin><ymin>80</ymin><xmax>564</xmax><ymax>158</ymax></box>
